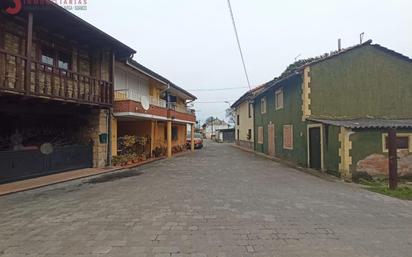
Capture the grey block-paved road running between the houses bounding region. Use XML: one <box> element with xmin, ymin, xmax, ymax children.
<box><xmin>0</xmin><ymin>143</ymin><xmax>412</xmax><ymax>257</ymax></box>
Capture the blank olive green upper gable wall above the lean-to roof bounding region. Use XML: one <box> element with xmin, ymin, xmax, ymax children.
<box><xmin>310</xmin><ymin>46</ymin><xmax>412</xmax><ymax>118</ymax></box>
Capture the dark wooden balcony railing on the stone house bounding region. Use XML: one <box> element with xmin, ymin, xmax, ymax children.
<box><xmin>0</xmin><ymin>49</ymin><xmax>113</xmax><ymax>105</ymax></box>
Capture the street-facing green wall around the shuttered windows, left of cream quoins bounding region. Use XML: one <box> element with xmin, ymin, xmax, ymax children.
<box><xmin>254</xmin><ymin>75</ymin><xmax>307</xmax><ymax>166</ymax></box>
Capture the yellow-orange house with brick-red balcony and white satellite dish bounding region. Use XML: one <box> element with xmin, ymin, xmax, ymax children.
<box><xmin>112</xmin><ymin>59</ymin><xmax>196</xmax><ymax>158</ymax></box>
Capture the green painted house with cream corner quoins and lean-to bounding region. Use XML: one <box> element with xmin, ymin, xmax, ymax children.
<box><xmin>254</xmin><ymin>41</ymin><xmax>412</xmax><ymax>178</ymax></box>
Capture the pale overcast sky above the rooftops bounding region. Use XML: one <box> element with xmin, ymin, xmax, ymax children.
<box><xmin>74</xmin><ymin>0</ymin><xmax>412</xmax><ymax>121</ymax></box>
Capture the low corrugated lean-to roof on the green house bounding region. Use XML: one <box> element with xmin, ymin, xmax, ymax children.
<box><xmin>308</xmin><ymin>118</ymin><xmax>412</xmax><ymax>129</ymax></box>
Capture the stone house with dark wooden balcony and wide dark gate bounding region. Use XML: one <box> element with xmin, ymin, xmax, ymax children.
<box><xmin>0</xmin><ymin>1</ymin><xmax>135</xmax><ymax>183</ymax></box>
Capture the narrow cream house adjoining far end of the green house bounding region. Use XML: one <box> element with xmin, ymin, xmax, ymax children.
<box><xmin>231</xmin><ymin>85</ymin><xmax>265</xmax><ymax>149</ymax></box>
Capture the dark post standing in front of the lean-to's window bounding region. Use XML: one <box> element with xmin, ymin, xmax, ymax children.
<box><xmin>388</xmin><ymin>128</ymin><xmax>398</xmax><ymax>190</ymax></box>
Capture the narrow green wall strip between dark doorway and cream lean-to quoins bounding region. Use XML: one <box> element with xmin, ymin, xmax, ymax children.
<box><xmin>323</xmin><ymin>126</ymin><xmax>340</xmax><ymax>176</ymax></box>
